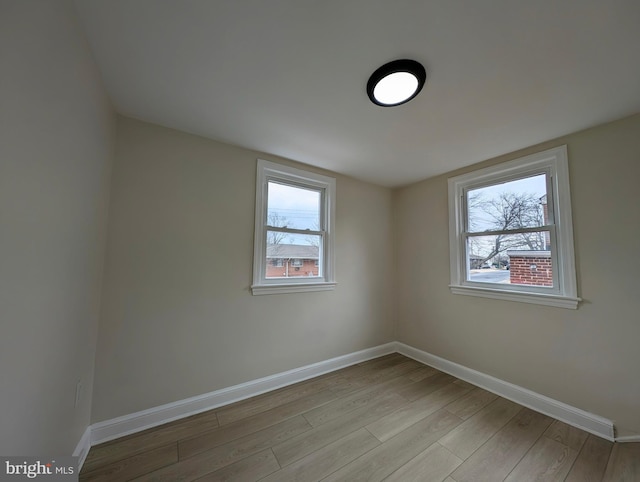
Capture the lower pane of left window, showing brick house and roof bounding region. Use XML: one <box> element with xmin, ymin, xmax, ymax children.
<box><xmin>265</xmin><ymin>231</ymin><xmax>322</xmax><ymax>278</ymax></box>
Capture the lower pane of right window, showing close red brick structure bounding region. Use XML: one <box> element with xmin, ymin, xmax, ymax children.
<box><xmin>467</xmin><ymin>231</ymin><xmax>553</xmax><ymax>287</ymax></box>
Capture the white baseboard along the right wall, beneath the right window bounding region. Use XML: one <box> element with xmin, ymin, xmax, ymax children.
<box><xmin>396</xmin><ymin>342</ymin><xmax>616</xmax><ymax>442</ymax></box>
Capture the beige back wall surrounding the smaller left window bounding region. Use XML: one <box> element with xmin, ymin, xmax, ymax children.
<box><xmin>92</xmin><ymin>117</ymin><xmax>394</xmax><ymax>422</ymax></box>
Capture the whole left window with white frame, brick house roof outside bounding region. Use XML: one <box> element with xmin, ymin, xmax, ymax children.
<box><xmin>251</xmin><ymin>159</ymin><xmax>336</xmax><ymax>295</ymax></box>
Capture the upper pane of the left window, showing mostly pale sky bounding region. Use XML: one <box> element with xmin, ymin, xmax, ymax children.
<box><xmin>267</xmin><ymin>181</ymin><xmax>321</xmax><ymax>231</ymax></box>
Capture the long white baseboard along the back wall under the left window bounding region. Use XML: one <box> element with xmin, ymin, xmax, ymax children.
<box><xmin>91</xmin><ymin>342</ymin><xmax>396</xmax><ymax>445</ymax></box>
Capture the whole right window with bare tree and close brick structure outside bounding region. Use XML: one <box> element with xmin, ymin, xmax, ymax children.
<box><xmin>449</xmin><ymin>146</ymin><xmax>580</xmax><ymax>309</ymax></box>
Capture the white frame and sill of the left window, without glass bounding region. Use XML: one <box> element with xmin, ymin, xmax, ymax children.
<box><xmin>251</xmin><ymin>159</ymin><xmax>337</xmax><ymax>295</ymax></box>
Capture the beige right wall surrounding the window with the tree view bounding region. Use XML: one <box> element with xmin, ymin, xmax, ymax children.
<box><xmin>394</xmin><ymin>115</ymin><xmax>640</xmax><ymax>435</ymax></box>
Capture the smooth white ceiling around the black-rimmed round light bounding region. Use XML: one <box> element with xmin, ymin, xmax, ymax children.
<box><xmin>76</xmin><ymin>0</ymin><xmax>640</xmax><ymax>186</ymax></box>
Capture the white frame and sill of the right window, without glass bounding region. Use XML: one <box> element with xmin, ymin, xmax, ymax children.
<box><xmin>449</xmin><ymin>146</ymin><xmax>581</xmax><ymax>309</ymax></box>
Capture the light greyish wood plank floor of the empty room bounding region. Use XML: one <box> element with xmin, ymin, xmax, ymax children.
<box><xmin>80</xmin><ymin>354</ymin><xmax>640</xmax><ymax>482</ymax></box>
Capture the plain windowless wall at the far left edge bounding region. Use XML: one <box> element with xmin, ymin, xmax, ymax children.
<box><xmin>0</xmin><ymin>0</ymin><xmax>115</xmax><ymax>455</ymax></box>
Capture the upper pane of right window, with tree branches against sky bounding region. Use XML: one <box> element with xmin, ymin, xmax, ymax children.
<box><xmin>466</xmin><ymin>174</ymin><xmax>548</xmax><ymax>232</ymax></box>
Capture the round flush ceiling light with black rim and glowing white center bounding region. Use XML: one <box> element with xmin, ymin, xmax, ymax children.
<box><xmin>367</xmin><ymin>59</ymin><xmax>427</xmax><ymax>107</ymax></box>
